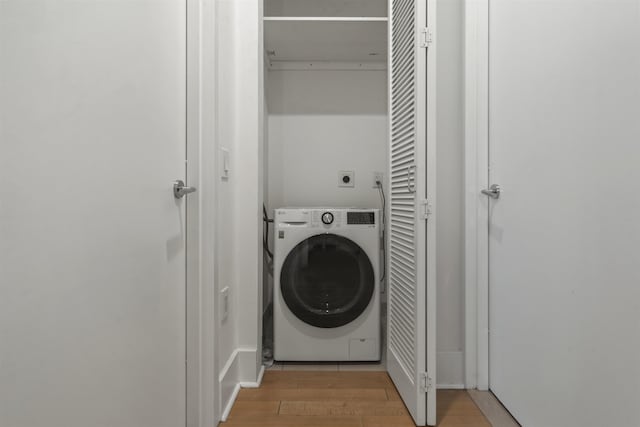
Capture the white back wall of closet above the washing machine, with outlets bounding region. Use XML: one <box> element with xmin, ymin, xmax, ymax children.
<box><xmin>267</xmin><ymin>71</ymin><xmax>388</xmax><ymax>211</ymax></box>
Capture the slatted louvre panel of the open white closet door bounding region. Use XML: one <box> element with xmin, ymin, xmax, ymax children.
<box><xmin>389</xmin><ymin>0</ymin><xmax>418</xmax><ymax>384</ymax></box>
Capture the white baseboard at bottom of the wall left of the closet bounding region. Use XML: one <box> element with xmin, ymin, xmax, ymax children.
<box><xmin>218</xmin><ymin>348</ymin><xmax>264</xmax><ymax>421</ymax></box>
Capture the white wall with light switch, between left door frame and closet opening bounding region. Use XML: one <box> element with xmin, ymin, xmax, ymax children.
<box><xmin>215</xmin><ymin>0</ymin><xmax>263</xmax><ymax>418</ymax></box>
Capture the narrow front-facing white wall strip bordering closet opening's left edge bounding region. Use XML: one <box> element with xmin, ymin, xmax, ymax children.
<box><xmin>230</xmin><ymin>0</ymin><xmax>264</xmax><ymax>382</ymax></box>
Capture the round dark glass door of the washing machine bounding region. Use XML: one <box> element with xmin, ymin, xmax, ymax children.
<box><xmin>280</xmin><ymin>234</ymin><xmax>375</xmax><ymax>328</ymax></box>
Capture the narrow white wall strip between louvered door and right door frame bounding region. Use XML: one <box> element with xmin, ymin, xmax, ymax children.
<box><xmin>436</xmin><ymin>0</ymin><xmax>464</xmax><ymax>386</ymax></box>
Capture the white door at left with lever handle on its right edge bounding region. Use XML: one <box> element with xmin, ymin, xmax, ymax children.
<box><xmin>0</xmin><ymin>0</ymin><xmax>186</xmax><ymax>427</ymax></box>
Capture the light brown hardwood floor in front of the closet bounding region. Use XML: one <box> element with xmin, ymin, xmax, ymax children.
<box><xmin>220</xmin><ymin>370</ymin><xmax>491</xmax><ymax>427</ymax></box>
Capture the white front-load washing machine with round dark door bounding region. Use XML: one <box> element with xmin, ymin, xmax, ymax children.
<box><xmin>273</xmin><ymin>208</ymin><xmax>381</xmax><ymax>361</ymax></box>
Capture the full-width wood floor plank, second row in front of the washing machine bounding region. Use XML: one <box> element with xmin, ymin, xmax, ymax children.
<box><xmin>237</xmin><ymin>388</ymin><xmax>387</xmax><ymax>401</ymax></box>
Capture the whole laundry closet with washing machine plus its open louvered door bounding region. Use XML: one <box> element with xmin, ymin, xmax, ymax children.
<box><xmin>252</xmin><ymin>0</ymin><xmax>435</xmax><ymax>425</ymax></box>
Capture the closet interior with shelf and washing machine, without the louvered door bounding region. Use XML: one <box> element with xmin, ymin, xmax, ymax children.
<box><xmin>262</xmin><ymin>0</ymin><xmax>389</xmax><ymax>371</ymax></box>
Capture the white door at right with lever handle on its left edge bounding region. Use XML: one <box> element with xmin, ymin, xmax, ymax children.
<box><xmin>489</xmin><ymin>0</ymin><xmax>640</xmax><ymax>427</ymax></box>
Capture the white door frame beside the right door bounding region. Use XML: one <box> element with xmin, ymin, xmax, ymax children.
<box><xmin>464</xmin><ymin>0</ymin><xmax>490</xmax><ymax>390</ymax></box>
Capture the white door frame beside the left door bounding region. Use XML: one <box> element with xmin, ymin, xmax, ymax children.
<box><xmin>185</xmin><ymin>0</ymin><xmax>221</xmax><ymax>427</ymax></box>
